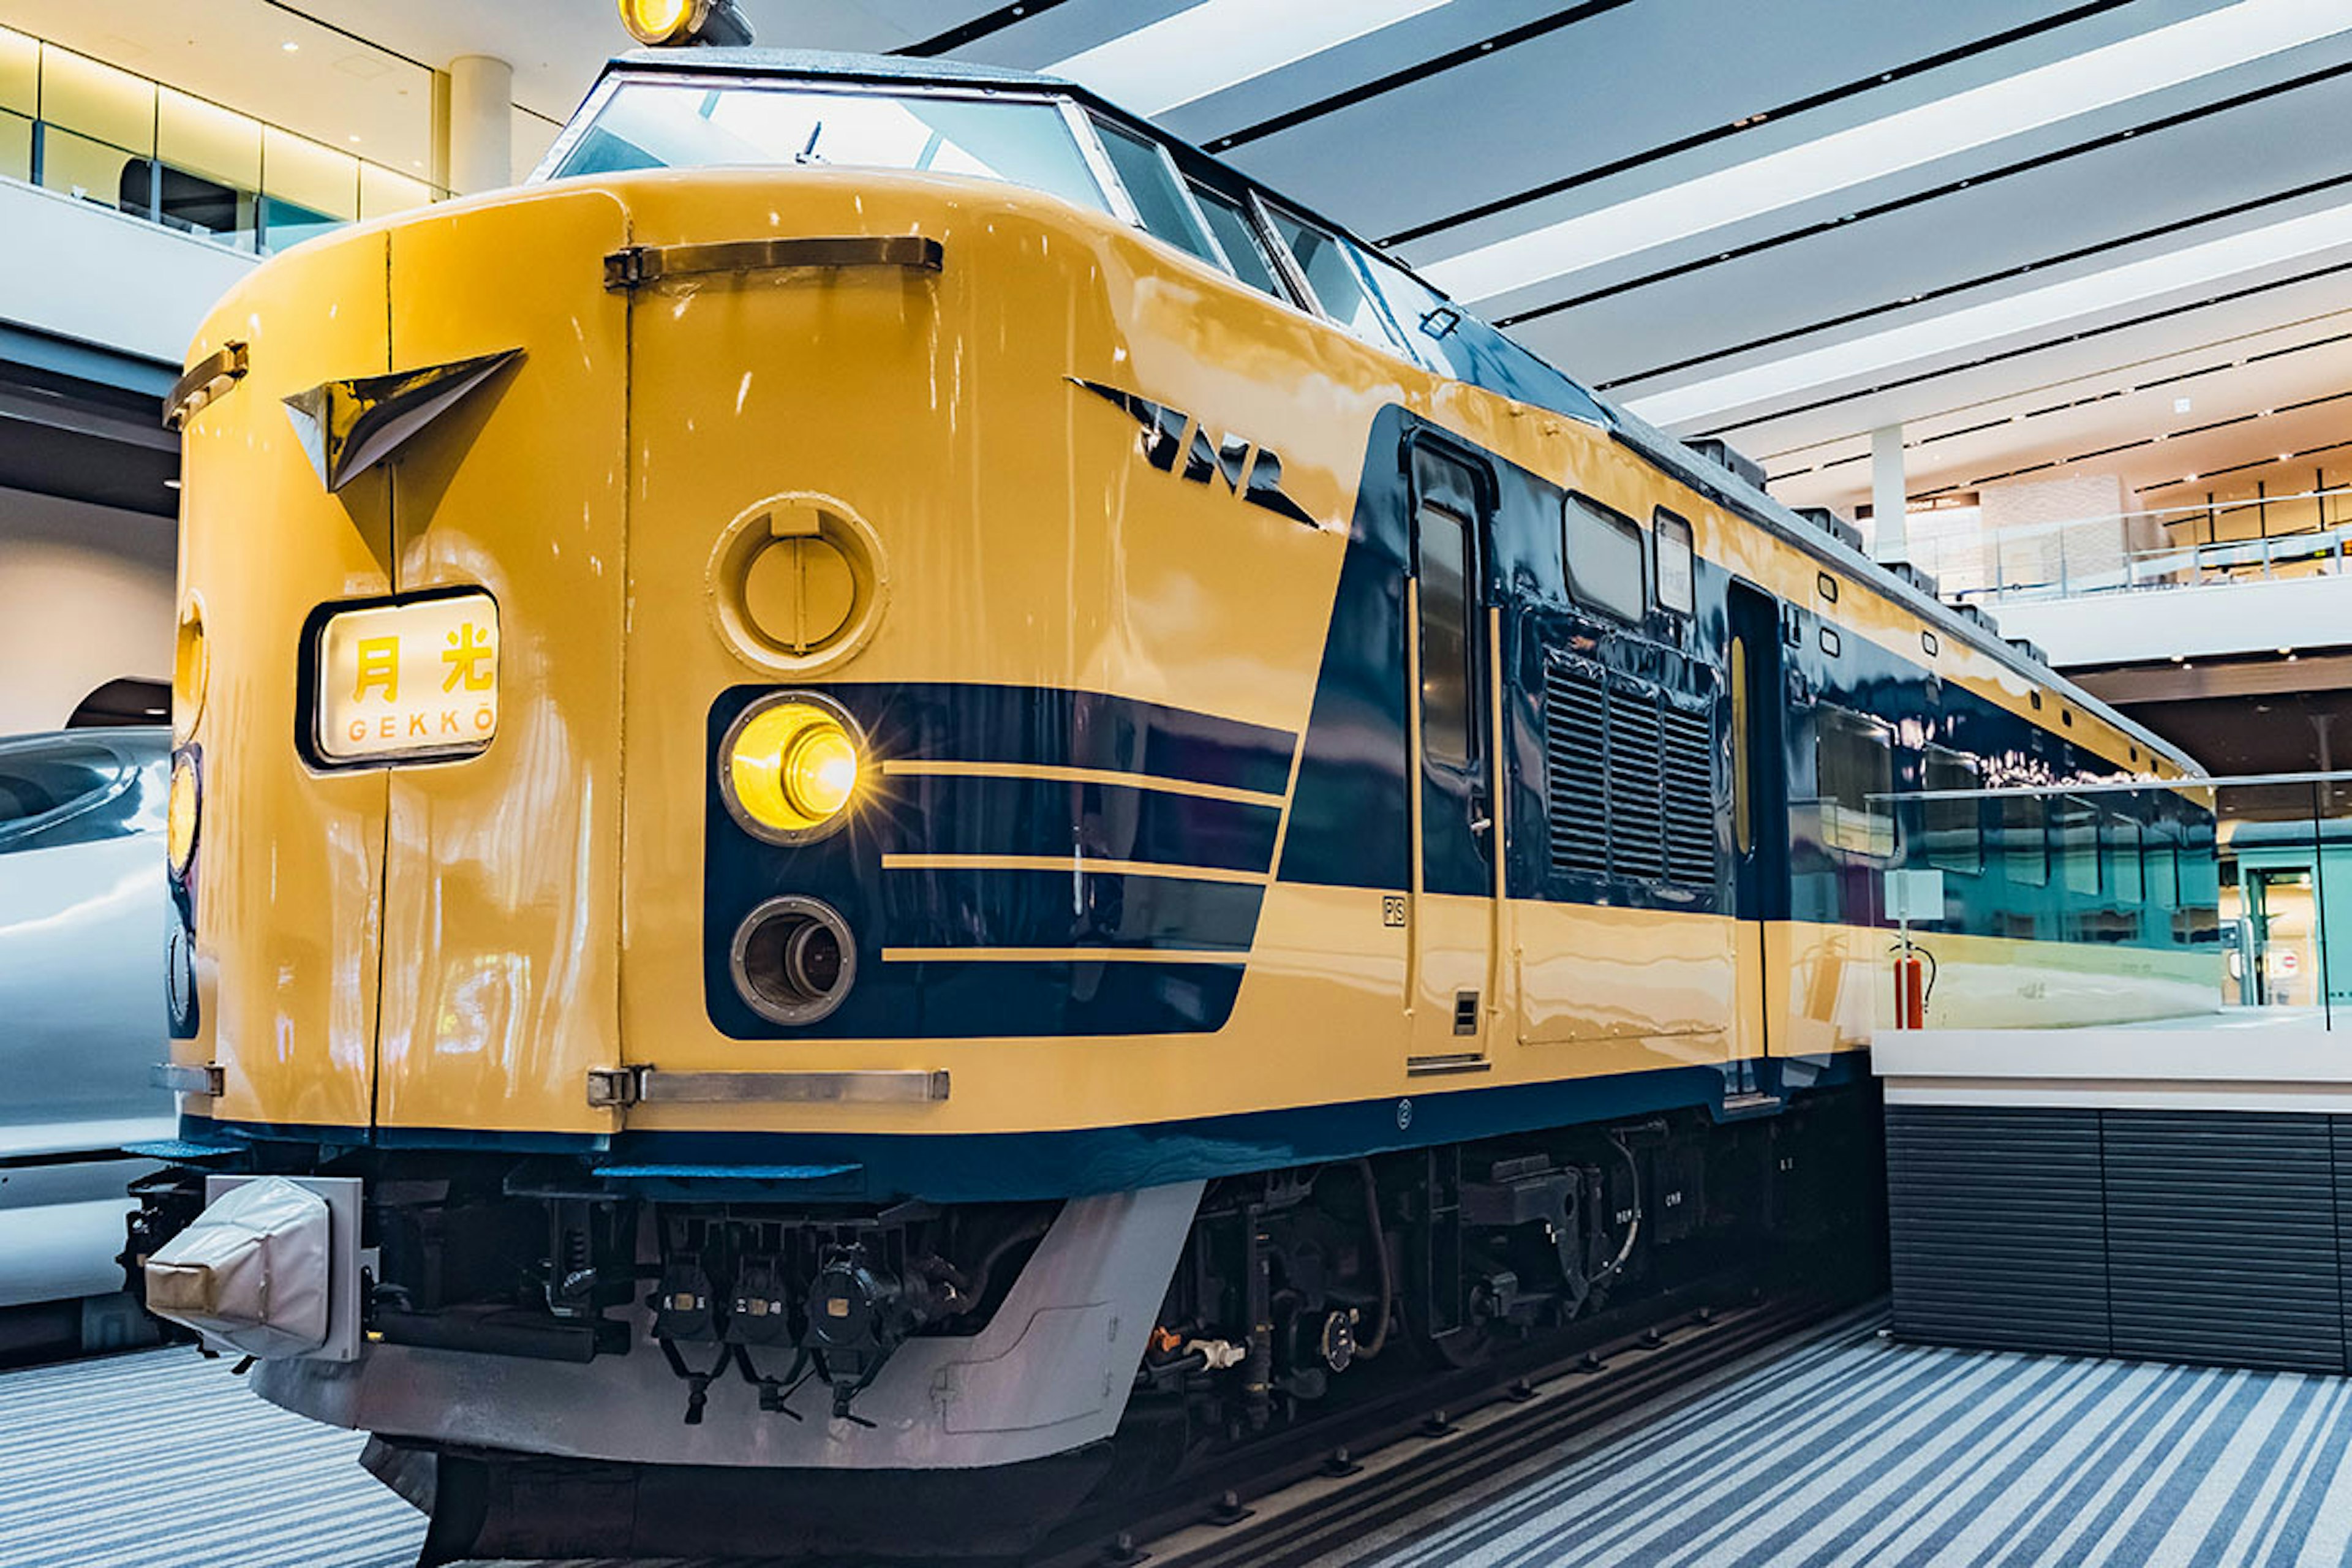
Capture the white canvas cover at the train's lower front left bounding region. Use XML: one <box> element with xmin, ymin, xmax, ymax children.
<box><xmin>146</xmin><ymin>1175</ymin><xmax>334</xmax><ymax>1357</ymax></box>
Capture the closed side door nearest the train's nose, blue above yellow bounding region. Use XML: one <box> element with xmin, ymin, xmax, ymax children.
<box><xmin>1406</xmin><ymin>442</ymin><xmax>1501</xmax><ymax>1074</ymax></box>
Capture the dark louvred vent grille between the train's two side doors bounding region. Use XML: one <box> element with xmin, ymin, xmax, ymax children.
<box><xmin>1543</xmin><ymin>658</ymin><xmax>1717</xmax><ymax>886</ymax></box>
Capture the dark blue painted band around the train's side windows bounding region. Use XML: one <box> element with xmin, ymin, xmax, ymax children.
<box><xmin>1282</xmin><ymin>407</ymin><xmax>2215</xmax><ymax>950</ymax></box>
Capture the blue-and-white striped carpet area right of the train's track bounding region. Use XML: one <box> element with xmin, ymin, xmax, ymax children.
<box><xmin>1324</xmin><ymin>1324</ymin><xmax>2352</xmax><ymax>1568</ymax></box>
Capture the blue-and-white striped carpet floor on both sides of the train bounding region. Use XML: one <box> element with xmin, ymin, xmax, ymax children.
<box><xmin>13</xmin><ymin>1321</ymin><xmax>2352</xmax><ymax>1568</ymax></box>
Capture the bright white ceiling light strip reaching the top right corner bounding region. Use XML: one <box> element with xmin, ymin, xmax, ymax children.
<box><xmin>1420</xmin><ymin>0</ymin><xmax>2352</xmax><ymax>301</ymax></box>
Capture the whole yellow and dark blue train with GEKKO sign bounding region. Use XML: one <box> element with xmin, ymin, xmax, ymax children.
<box><xmin>129</xmin><ymin>21</ymin><xmax>2218</xmax><ymax>1556</ymax></box>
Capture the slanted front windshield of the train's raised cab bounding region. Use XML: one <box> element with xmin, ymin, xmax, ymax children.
<box><xmin>555</xmin><ymin>82</ymin><xmax>1110</xmax><ymax>211</ymax></box>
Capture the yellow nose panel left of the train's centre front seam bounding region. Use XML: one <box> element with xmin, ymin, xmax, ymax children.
<box><xmin>172</xmin><ymin>230</ymin><xmax>393</xmax><ymax>1126</ymax></box>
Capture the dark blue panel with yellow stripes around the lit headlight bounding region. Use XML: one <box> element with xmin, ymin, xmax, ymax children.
<box><xmin>703</xmin><ymin>684</ymin><xmax>1291</xmax><ymax>1039</ymax></box>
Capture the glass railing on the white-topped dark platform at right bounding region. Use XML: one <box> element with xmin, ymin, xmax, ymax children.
<box><xmin>1872</xmin><ymin>774</ymin><xmax>2352</xmax><ymax>1030</ymax></box>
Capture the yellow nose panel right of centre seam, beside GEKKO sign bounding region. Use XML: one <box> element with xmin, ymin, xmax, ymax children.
<box><xmin>376</xmin><ymin>188</ymin><xmax>628</xmax><ymax>1131</ymax></box>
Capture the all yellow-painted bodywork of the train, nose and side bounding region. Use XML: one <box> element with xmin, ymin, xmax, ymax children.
<box><xmin>176</xmin><ymin>169</ymin><xmax>2211</xmax><ymax>1133</ymax></box>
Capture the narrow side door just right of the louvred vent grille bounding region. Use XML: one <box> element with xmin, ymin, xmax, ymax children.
<box><xmin>1724</xmin><ymin>583</ymin><xmax>1787</xmax><ymax>1060</ymax></box>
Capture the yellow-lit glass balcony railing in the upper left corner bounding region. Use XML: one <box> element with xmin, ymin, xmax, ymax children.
<box><xmin>0</xmin><ymin>28</ymin><xmax>449</xmax><ymax>254</ymax></box>
